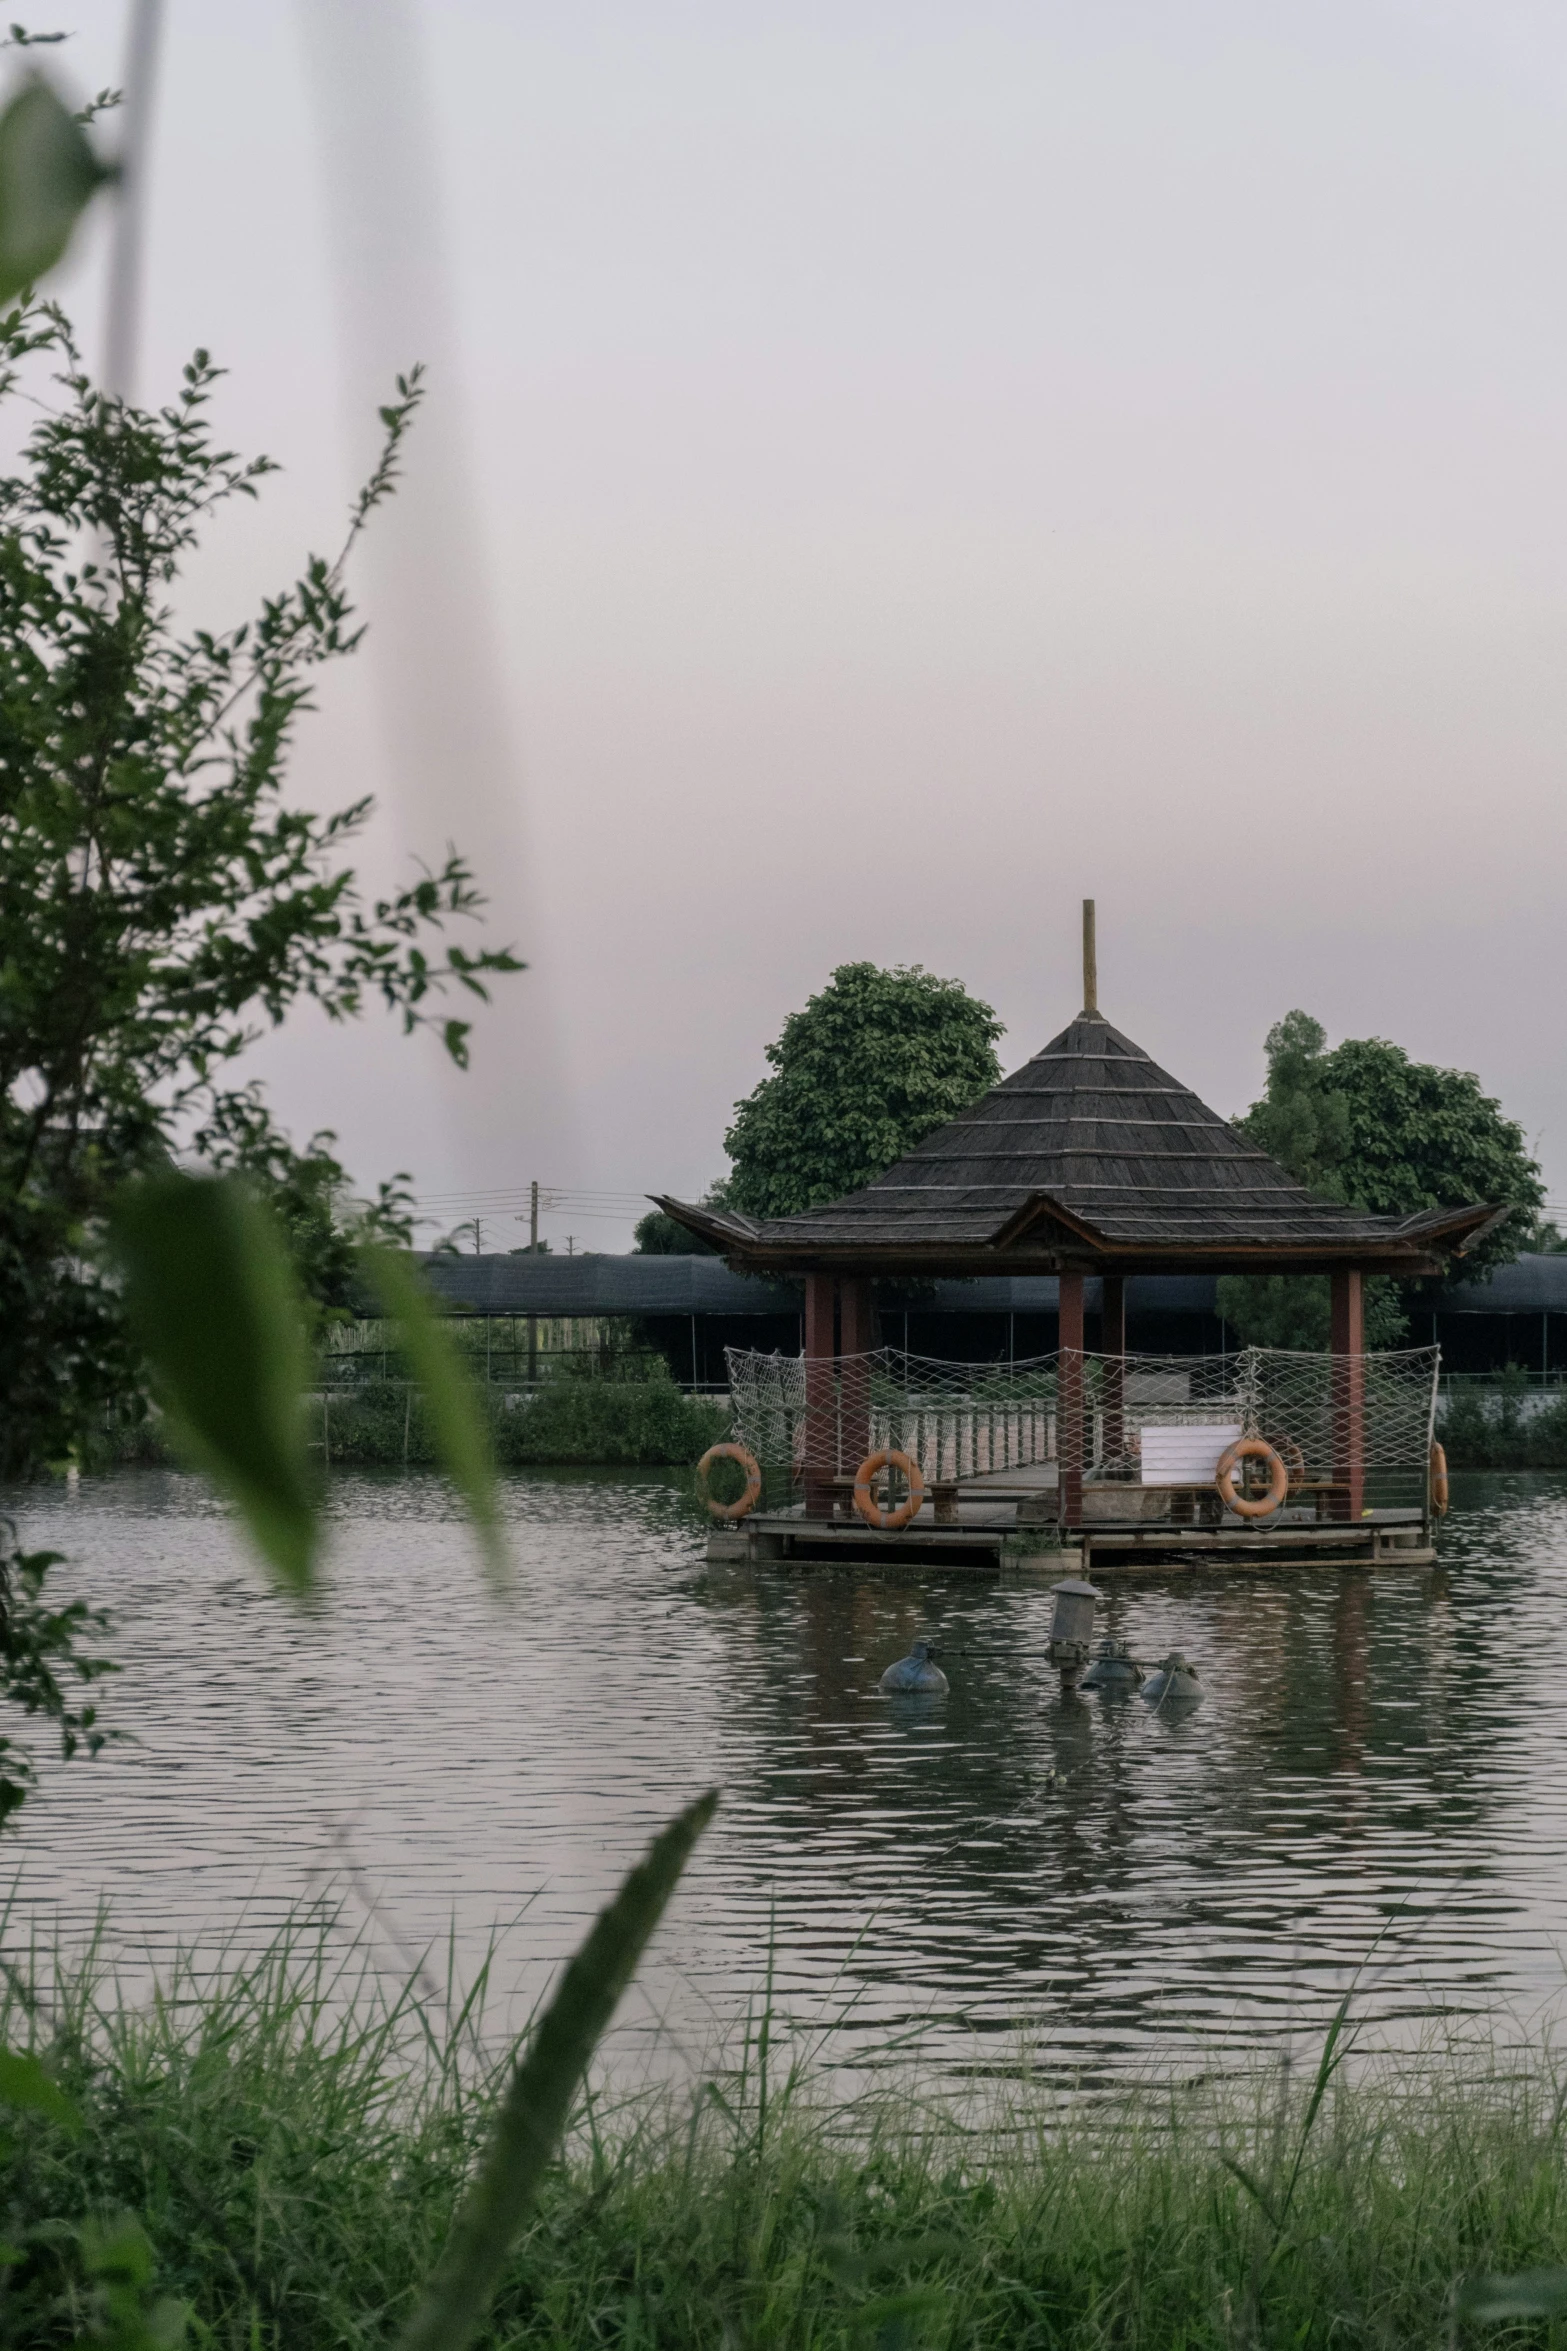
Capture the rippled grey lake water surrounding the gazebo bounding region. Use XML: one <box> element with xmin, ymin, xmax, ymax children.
<box><xmin>12</xmin><ymin>1472</ymin><xmax>1567</xmax><ymax>2081</ymax></box>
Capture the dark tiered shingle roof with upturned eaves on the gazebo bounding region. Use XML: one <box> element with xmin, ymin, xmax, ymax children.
<box><xmin>660</xmin><ymin>1013</ymin><xmax>1494</xmax><ymax>1274</ymax></box>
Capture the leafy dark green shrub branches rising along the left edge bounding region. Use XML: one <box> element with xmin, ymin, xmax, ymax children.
<box><xmin>0</xmin><ymin>308</ymin><xmax>517</xmax><ymax>1476</ymax></box>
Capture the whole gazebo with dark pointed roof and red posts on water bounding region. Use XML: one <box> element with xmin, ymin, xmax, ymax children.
<box><xmin>658</xmin><ymin>900</ymin><xmax>1506</xmax><ymax>1570</ymax></box>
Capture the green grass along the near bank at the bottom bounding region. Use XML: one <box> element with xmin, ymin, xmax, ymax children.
<box><xmin>0</xmin><ymin>1942</ymin><xmax>1567</xmax><ymax>2351</ymax></box>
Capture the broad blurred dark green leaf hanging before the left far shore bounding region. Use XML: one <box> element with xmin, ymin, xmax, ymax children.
<box><xmin>110</xmin><ymin>1171</ymin><xmax>317</xmax><ymax>1592</ymax></box>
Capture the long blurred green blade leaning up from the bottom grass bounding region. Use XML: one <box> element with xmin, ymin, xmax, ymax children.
<box><xmin>397</xmin><ymin>1789</ymin><xmax>719</xmax><ymax>2351</ymax></box>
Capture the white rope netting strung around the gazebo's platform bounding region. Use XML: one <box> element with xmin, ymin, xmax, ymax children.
<box><xmin>726</xmin><ymin>1347</ymin><xmax>1440</xmax><ymax>1514</ymax></box>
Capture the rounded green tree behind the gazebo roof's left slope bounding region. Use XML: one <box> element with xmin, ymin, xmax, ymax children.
<box><xmin>724</xmin><ymin>964</ymin><xmax>1001</xmax><ymax>1215</ymax></box>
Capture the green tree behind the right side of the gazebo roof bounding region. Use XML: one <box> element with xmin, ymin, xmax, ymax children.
<box><xmin>1219</xmin><ymin>1011</ymin><xmax>1546</xmax><ymax>1349</ymax></box>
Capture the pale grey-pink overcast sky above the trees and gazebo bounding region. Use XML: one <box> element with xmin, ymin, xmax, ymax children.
<box><xmin>42</xmin><ymin>0</ymin><xmax>1567</xmax><ymax>1246</ymax></box>
